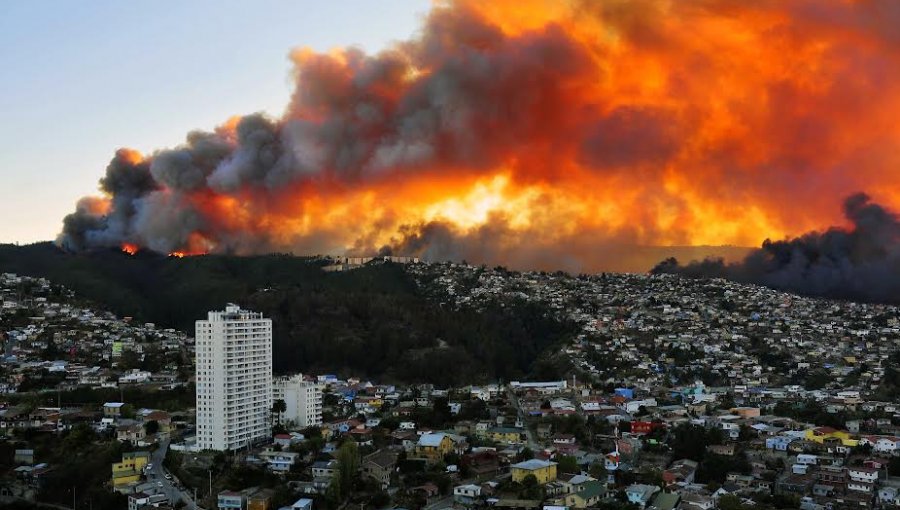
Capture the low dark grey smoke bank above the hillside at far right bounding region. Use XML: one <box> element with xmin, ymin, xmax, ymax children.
<box><xmin>651</xmin><ymin>193</ymin><xmax>900</xmax><ymax>303</ymax></box>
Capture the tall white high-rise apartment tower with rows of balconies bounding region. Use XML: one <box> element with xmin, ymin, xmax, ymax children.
<box><xmin>195</xmin><ymin>304</ymin><xmax>272</xmax><ymax>450</ymax></box>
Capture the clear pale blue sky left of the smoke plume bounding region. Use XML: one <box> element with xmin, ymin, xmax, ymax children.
<box><xmin>0</xmin><ymin>0</ymin><xmax>430</xmax><ymax>243</ymax></box>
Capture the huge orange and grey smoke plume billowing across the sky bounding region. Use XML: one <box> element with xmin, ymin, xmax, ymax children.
<box><xmin>58</xmin><ymin>0</ymin><xmax>900</xmax><ymax>271</ymax></box>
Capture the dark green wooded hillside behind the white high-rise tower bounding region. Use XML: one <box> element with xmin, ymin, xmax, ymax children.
<box><xmin>0</xmin><ymin>243</ymin><xmax>575</xmax><ymax>384</ymax></box>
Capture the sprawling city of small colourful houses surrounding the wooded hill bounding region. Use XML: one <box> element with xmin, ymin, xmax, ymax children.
<box><xmin>0</xmin><ymin>258</ymin><xmax>900</xmax><ymax>510</ymax></box>
